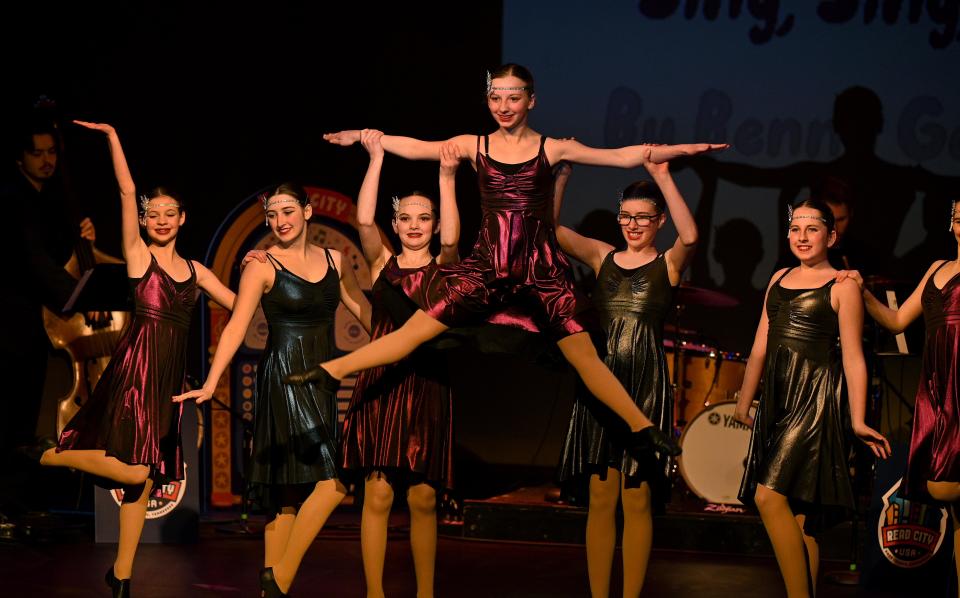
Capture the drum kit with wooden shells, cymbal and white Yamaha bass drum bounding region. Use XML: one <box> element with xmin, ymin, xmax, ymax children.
<box><xmin>664</xmin><ymin>283</ymin><xmax>750</xmax><ymax>505</ymax></box>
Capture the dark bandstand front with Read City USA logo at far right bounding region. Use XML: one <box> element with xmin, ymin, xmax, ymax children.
<box><xmin>860</xmin><ymin>442</ymin><xmax>956</xmax><ymax>598</ymax></box>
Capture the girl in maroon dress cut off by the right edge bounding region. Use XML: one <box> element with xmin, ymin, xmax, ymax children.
<box><xmin>840</xmin><ymin>202</ymin><xmax>960</xmax><ymax>584</ymax></box>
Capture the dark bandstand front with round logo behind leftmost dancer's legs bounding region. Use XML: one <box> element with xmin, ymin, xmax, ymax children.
<box><xmin>94</xmin><ymin>403</ymin><xmax>201</xmax><ymax>544</ymax></box>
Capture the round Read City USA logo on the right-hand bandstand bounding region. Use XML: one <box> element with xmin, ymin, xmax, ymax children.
<box><xmin>877</xmin><ymin>479</ymin><xmax>947</xmax><ymax>569</ymax></box>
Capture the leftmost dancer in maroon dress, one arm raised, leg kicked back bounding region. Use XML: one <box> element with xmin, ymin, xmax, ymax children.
<box><xmin>40</xmin><ymin>121</ymin><xmax>235</xmax><ymax>596</ymax></box>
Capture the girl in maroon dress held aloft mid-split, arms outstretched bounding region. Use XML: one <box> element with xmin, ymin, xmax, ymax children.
<box><xmin>289</xmin><ymin>64</ymin><xmax>726</xmax><ymax>455</ymax></box>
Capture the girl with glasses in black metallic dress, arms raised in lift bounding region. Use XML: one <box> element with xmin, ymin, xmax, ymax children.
<box><xmin>554</xmin><ymin>160</ymin><xmax>697</xmax><ymax>596</ymax></box>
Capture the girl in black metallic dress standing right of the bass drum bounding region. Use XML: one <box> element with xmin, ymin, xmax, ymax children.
<box><xmin>736</xmin><ymin>199</ymin><xmax>890</xmax><ymax>597</ymax></box>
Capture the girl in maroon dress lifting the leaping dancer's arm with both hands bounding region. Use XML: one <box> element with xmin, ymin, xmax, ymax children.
<box><xmin>341</xmin><ymin>131</ymin><xmax>460</xmax><ymax>597</ymax></box>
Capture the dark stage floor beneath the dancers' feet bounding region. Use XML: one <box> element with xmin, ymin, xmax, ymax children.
<box><xmin>0</xmin><ymin>506</ymin><xmax>881</xmax><ymax>598</ymax></box>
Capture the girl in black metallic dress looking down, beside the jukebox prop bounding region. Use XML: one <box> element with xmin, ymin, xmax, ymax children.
<box><xmin>175</xmin><ymin>183</ymin><xmax>370</xmax><ymax>597</ymax></box>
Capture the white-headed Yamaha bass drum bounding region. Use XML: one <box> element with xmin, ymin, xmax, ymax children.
<box><xmin>677</xmin><ymin>401</ymin><xmax>753</xmax><ymax>505</ymax></box>
